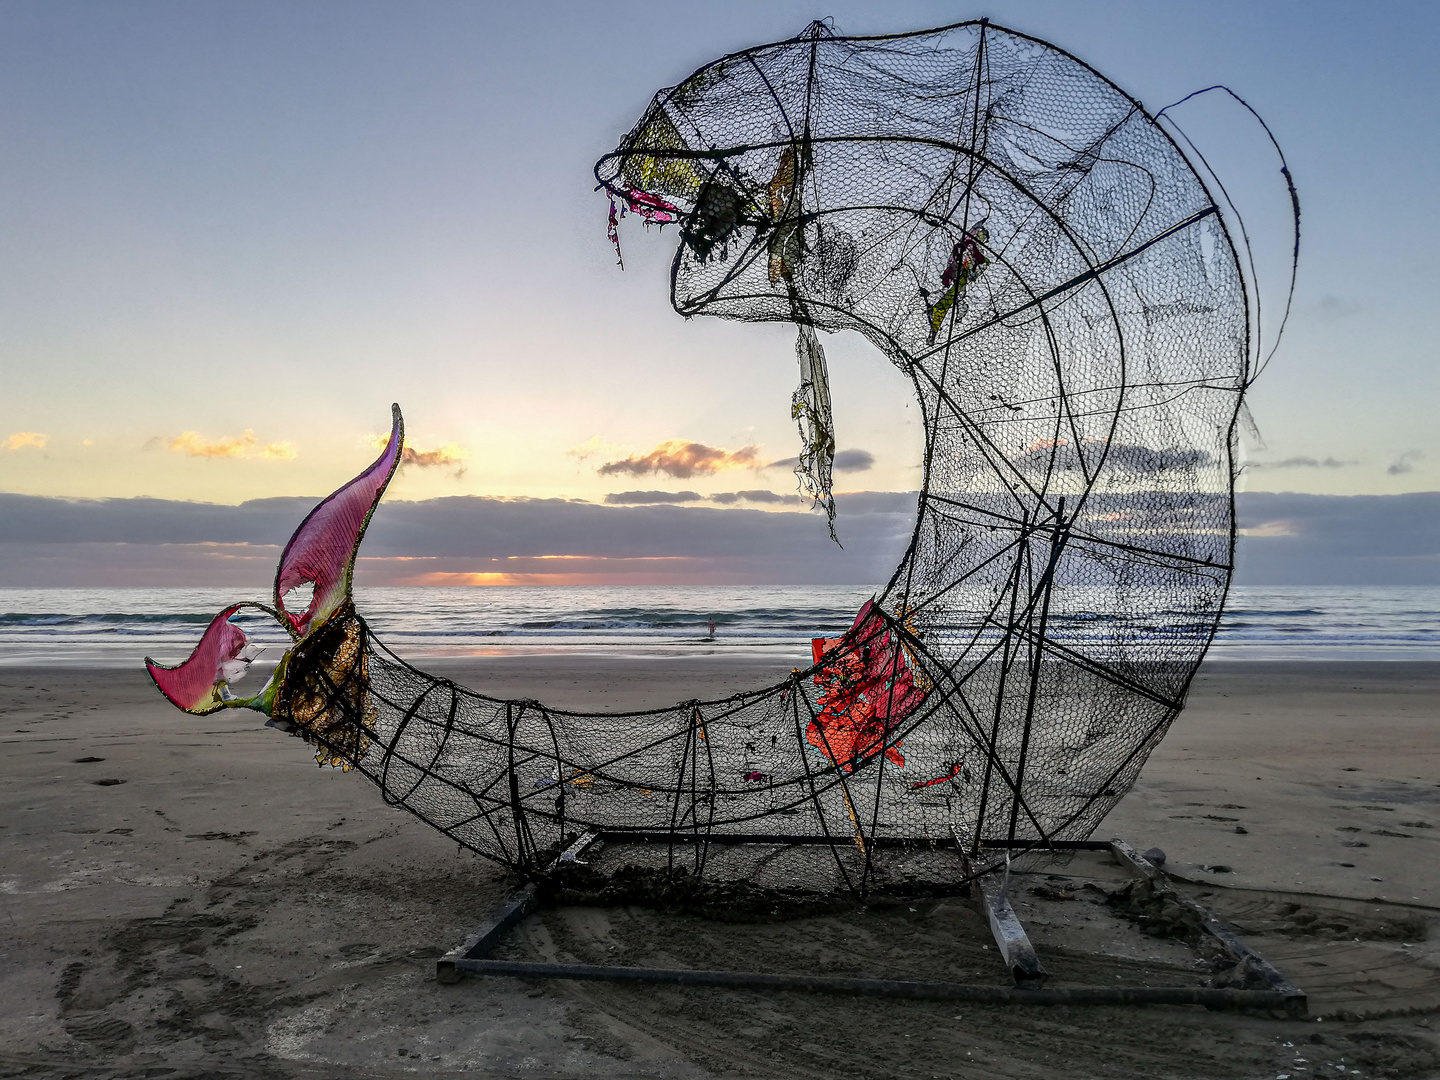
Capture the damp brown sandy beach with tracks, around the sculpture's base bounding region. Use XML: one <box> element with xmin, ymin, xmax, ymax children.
<box><xmin>0</xmin><ymin>655</ymin><xmax>1440</xmax><ymax>1077</ymax></box>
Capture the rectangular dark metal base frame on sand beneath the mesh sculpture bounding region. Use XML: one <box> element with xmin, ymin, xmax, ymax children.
<box><xmin>435</xmin><ymin>829</ymin><xmax>1306</xmax><ymax>1015</ymax></box>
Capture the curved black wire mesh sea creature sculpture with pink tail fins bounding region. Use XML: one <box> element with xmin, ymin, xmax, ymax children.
<box><xmin>147</xmin><ymin>22</ymin><xmax>1293</xmax><ymax>897</ymax></box>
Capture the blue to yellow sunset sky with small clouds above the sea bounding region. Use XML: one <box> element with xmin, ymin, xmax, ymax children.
<box><xmin>0</xmin><ymin>0</ymin><xmax>1440</xmax><ymax>585</ymax></box>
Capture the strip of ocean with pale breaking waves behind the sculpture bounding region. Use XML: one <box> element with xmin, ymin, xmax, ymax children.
<box><xmin>0</xmin><ymin>586</ymin><xmax>1440</xmax><ymax>667</ymax></box>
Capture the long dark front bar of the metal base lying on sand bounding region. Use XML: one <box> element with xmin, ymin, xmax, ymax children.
<box><xmin>454</xmin><ymin>959</ymin><xmax>1305</xmax><ymax>1009</ymax></box>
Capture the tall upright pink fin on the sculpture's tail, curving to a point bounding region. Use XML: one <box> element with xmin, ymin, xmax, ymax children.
<box><xmin>275</xmin><ymin>405</ymin><xmax>405</xmax><ymax>638</ymax></box>
